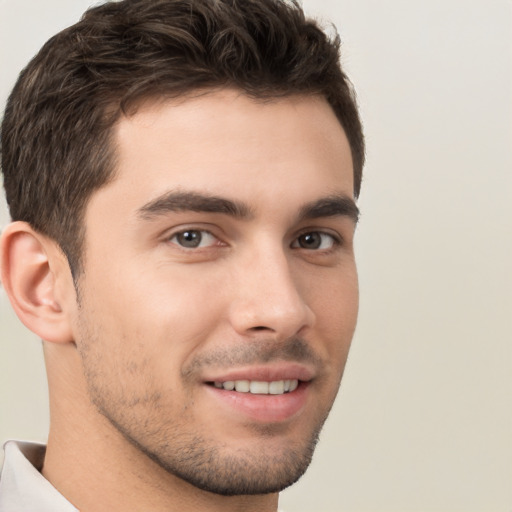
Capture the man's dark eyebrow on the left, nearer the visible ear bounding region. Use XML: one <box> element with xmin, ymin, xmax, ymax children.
<box><xmin>137</xmin><ymin>191</ymin><xmax>252</xmax><ymax>220</ymax></box>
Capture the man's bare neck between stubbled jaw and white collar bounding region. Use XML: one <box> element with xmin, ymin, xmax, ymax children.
<box><xmin>43</xmin><ymin>344</ymin><xmax>278</xmax><ymax>512</ymax></box>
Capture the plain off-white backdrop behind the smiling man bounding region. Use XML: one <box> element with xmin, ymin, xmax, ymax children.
<box><xmin>0</xmin><ymin>0</ymin><xmax>512</xmax><ymax>512</ymax></box>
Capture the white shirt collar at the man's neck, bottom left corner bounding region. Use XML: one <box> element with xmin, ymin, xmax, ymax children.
<box><xmin>0</xmin><ymin>441</ymin><xmax>78</xmax><ymax>512</ymax></box>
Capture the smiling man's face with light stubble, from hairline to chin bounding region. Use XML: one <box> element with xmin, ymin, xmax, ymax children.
<box><xmin>74</xmin><ymin>90</ymin><xmax>358</xmax><ymax>495</ymax></box>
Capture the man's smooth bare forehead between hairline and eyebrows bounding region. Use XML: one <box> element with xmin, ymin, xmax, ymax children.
<box><xmin>91</xmin><ymin>90</ymin><xmax>353</xmax><ymax>218</ymax></box>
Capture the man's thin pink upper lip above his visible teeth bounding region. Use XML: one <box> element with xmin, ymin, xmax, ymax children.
<box><xmin>203</xmin><ymin>363</ymin><xmax>315</xmax><ymax>382</ymax></box>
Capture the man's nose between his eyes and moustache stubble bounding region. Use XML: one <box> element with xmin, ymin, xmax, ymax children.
<box><xmin>229</xmin><ymin>245</ymin><xmax>315</xmax><ymax>340</ymax></box>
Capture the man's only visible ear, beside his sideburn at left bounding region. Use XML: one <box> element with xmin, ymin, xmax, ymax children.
<box><xmin>0</xmin><ymin>221</ymin><xmax>76</xmax><ymax>343</ymax></box>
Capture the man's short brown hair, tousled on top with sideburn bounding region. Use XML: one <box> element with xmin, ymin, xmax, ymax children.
<box><xmin>1</xmin><ymin>0</ymin><xmax>364</xmax><ymax>276</ymax></box>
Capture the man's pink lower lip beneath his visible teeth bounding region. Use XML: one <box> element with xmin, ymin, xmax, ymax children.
<box><xmin>206</xmin><ymin>382</ymin><xmax>309</xmax><ymax>423</ymax></box>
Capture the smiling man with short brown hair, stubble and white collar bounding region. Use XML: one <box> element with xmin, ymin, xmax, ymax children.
<box><xmin>0</xmin><ymin>0</ymin><xmax>364</xmax><ymax>512</ymax></box>
